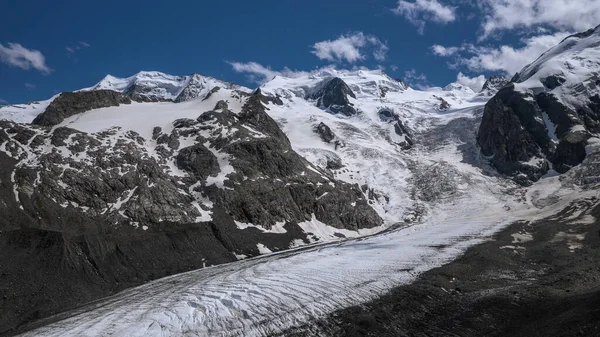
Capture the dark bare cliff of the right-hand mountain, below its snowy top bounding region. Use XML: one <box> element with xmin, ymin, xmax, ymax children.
<box><xmin>477</xmin><ymin>85</ymin><xmax>593</xmax><ymax>184</ymax></box>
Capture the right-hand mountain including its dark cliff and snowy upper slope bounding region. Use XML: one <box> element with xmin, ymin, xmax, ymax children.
<box><xmin>478</xmin><ymin>26</ymin><xmax>600</xmax><ymax>184</ymax></box>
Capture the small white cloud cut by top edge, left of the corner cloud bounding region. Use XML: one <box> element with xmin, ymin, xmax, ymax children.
<box><xmin>392</xmin><ymin>0</ymin><xmax>456</xmax><ymax>34</ymax></box>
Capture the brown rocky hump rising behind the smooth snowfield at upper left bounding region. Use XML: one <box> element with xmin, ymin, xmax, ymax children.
<box><xmin>33</xmin><ymin>90</ymin><xmax>131</xmax><ymax>126</ymax></box>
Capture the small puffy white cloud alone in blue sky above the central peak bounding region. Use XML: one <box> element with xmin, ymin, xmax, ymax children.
<box><xmin>312</xmin><ymin>32</ymin><xmax>388</xmax><ymax>63</ymax></box>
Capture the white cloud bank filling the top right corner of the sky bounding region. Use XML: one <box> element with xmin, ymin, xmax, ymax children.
<box><xmin>479</xmin><ymin>0</ymin><xmax>600</xmax><ymax>37</ymax></box>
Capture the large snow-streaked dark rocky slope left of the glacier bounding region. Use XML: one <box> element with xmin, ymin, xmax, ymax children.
<box><xmin>0</xmin><ymin>92</ymin><xmax>382</xmax><ymax>332</ymax></box>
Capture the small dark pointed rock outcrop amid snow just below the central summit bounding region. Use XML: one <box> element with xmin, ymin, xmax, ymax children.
<box><xmin>307</xmin><ymin>77</ymin><xmax>358</xmax><ymax>116</ymax></box>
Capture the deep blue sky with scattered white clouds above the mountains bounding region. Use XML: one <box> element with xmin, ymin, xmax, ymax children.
<box><xmin>0</xmin><ymin>0</ymin><xmax>600</xmax><ymax>104</ymax></box>
